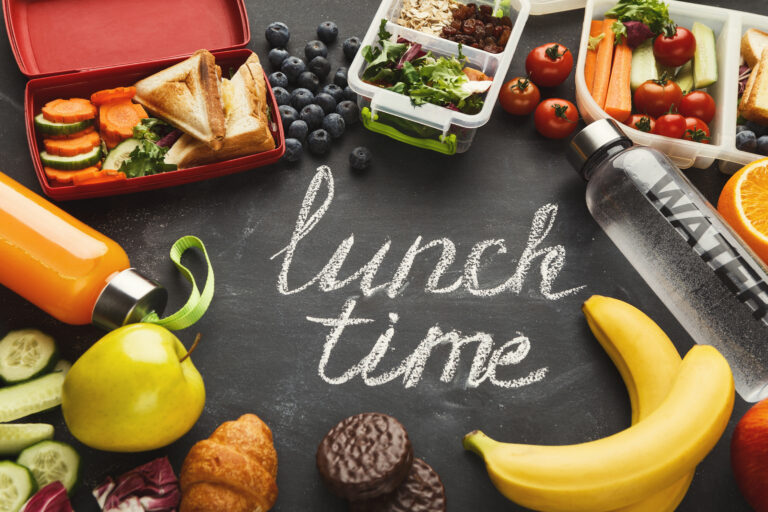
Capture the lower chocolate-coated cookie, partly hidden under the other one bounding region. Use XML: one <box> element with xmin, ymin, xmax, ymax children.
<box><xmin>349</xmin><ymin>459</ymin><xmax>445</xmax><ymax>512</ymax></box>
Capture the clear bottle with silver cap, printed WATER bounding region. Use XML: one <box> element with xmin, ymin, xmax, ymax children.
<box><xmin>568</xmin><ymin>120</ymin><xmax>768</xmax><ymax>402</ymax></box>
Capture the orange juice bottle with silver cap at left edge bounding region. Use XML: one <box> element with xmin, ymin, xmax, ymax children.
<box><xmin>0</xmin><ymin>173</ymin><xmax>167</xmax><ymax>329</ymax></box>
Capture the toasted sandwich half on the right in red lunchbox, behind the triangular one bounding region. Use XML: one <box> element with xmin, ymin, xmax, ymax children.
<box><xmin>165</xmin><ymin>53</ymin><xmax>275</xmax><ymax>169</ymax></box>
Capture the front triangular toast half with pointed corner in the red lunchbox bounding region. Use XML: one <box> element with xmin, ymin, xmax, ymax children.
<box><xmin>134</xmin><ymin>50</ymin><xmax>226</xmax><ymax>149</ymax></box>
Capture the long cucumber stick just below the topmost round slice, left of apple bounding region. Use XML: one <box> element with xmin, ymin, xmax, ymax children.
<box><xmin>0</xmin><ymin>372</ymin><xmax>64</xmax><ymax>423</ymax></box>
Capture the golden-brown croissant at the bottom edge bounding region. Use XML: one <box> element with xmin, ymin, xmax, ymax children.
<box><xmin>179</xmin><ymin>414</ymin><xmax>277</xmax><ymax>512</ymax></box>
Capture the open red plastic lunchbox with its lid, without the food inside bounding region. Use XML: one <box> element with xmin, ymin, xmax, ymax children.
<box><xmin>3</xmin><ymin>0</ymin><xmax>285</xmax><ymax>200</ymax></box>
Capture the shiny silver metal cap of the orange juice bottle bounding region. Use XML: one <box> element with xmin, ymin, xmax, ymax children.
<box><xmin>91</xmin><ymin>268</ymin><xmax>168</xmax><ymax>331</ymax></box>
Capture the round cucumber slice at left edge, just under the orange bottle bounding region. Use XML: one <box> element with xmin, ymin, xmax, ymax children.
<box><xmin>0</xmin><ymin>329</ymin><xmax>57</xmax><ymax>384</ymax></box>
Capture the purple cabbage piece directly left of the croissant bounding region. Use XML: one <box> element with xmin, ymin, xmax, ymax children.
<box><xmin>93</xmin><ymin>457</ymin><xmax>181</xmax><ymax>512</ymax></box>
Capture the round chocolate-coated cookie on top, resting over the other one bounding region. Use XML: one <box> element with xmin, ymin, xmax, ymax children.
<box><xmin>317</xmin><ymin>412</ymin><xmax>413</xmax><ymax>501</ymax></box>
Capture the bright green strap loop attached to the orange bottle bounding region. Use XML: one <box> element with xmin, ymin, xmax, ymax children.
<box><xmin>141</xmin><ymin>235</ymin><xmax>213</xmax><ymax>331</ymax></box>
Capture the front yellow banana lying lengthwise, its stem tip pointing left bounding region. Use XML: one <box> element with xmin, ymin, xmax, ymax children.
<box><xmin>464</xmin><ymin>345</ymin><xmax>734</xmax><ymax>512</ymax></box>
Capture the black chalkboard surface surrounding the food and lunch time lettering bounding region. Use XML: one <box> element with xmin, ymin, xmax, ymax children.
<box><xmin>0</xmin><ymin>0</ymin><xmax>768</xmax><ymax>511</ymax></box>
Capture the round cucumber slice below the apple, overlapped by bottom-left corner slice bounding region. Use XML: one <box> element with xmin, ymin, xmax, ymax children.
<box><xmin>16</xmin><ymin>441</ymin><xmax>80</xmax><ymax>492</ymax></box>
